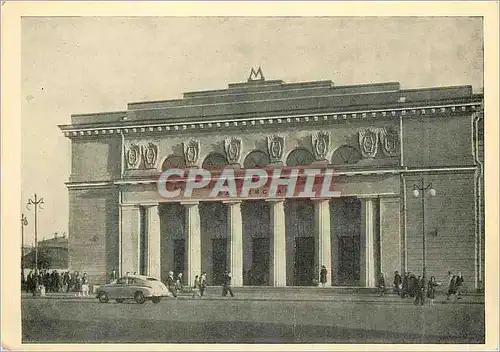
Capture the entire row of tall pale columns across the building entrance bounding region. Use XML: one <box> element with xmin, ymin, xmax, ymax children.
<box><xmin>120</xmin><ymin>199</ymin><xmax>376</xmax><ymax>287</ymax></box>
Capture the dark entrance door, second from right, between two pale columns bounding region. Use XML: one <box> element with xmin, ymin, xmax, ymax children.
<box><xmin>294</xmin><ymin>237</ymin><xmax>315</xmax><ymax>286</ymax></box>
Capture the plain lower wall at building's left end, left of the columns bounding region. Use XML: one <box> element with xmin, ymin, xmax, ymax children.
<box><xmin>68</xmin><ymin>188</ymin><xmax>119</xmax><ymax>283</ymax></box>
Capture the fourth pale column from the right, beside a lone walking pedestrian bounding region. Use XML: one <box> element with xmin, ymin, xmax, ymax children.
<box><xmin>224</xmin><ymin>202</ymin><xmax>243</xmax><ymax>287</ymax></box>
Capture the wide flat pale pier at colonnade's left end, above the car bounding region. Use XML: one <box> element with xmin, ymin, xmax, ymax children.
<box><xmin>119</xmin><ymin>204</ymin><xmax>141</xmax><ymax>275</ymax></box>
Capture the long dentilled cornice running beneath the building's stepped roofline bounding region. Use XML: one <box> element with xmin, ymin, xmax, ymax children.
<box><xmin>59</xmin><ymin>102</ymin><xmax>481</xmax><ymax>138</ymax></box>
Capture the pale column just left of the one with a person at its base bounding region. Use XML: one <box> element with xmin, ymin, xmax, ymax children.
<box><xmin>269</xmin><ymin>200</ymin><xmax>286</xmax><ymax>287</ymax></box>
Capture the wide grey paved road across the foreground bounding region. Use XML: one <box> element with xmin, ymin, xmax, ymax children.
<box><xmin>22</xmin><ymin>297</ymin><xmax>484</xmax><ymax>343</ymax></box>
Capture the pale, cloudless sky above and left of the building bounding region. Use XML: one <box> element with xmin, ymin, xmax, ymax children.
<box><xmin>20</xmin><ymin>17</ymin><xmax>484</xmax><ymax>245</ymax></box>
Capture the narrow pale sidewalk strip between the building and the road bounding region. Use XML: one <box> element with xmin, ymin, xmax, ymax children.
<box><xmin>21</xmin><ymin>287</ymin><xmax>484</xmax><ymax>305</ymax></box>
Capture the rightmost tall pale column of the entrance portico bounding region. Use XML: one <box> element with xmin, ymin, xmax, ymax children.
<box><xmin>360</xmin><ymin>198</ymin><xmax>376</xmax><ymax>287</ymax></box>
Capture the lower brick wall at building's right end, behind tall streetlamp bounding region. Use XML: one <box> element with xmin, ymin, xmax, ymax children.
<box><xmin>406</xmin><ymin>173</ymin><xmax>475</xmax><ymax>290</ymax></box>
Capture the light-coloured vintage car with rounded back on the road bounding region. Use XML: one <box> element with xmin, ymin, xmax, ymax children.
<box><xmin>97</xmin><ymin>275</ymin><xmax>170</xmax><ymax>304</ymax></box>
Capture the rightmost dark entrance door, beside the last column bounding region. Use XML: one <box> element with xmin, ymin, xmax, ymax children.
<box><xmin>339</xmin><ymin>236</ymin><xmax>360</xmax><ymax>286</ymax></box>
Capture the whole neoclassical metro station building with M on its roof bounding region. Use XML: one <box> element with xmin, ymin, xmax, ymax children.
<box><xmin>60</xmin><ymin>72</ymin><xmax>484</xmax><ymax>289</ymax></box>
